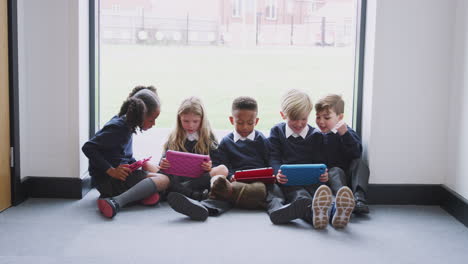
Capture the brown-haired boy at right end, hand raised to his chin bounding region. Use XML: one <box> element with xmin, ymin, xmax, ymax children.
<box><xmin>315</xmin><ymin>94</ymin><xmax>369</xmax><ymax>214</ymax></box>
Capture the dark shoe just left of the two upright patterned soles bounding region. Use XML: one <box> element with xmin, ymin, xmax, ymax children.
<box><xmin>270</xmin><ymin>198</ymin><xmax>312</xmax><ymax>225</ymax></box>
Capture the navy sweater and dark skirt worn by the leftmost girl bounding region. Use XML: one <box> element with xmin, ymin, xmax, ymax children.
<box><xmin>82</xmin><ymin>115</ymin><xmax>147</xmax><ymax>197</ymax></box>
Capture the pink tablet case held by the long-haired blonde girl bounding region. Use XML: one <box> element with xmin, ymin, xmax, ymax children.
<box><xmin>164</xmin><ymin>150</ymin><xmax>210</xmax><ymax>178</ymax></box>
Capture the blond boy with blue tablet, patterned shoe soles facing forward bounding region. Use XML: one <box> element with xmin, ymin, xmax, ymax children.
<box><xmin>269</xmin><ymin>90</ymin><xmax>354</xmax><ymax>229</ymax></box>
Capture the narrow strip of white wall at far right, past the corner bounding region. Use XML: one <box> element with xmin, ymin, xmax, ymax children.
<box><xmin>445</xmin><ymin>0</ymin><xmax>468</xmax><ymax>199</ymax></box>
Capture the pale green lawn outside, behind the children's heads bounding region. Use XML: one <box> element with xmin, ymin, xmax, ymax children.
<box><xmin>100</xmin><ymin>44</ymin><xmax>354</xmax><ymax>130</ymax></box>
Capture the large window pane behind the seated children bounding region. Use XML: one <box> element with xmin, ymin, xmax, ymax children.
<box><xmin>98</xmin><ymin>0</ymin><xmax>364</xmax><ymax>159</ymax></box>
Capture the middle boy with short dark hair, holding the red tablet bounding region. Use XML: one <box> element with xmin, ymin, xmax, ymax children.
<box><xmin>168</xmin><ymin>97</ymin><xmax>284</xmax><ymax>220</ymax></box>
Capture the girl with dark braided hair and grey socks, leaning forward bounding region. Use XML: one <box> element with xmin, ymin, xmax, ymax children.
<box><xmin>82</xmin><ymin>86</ymin><xmax>169</xmax><ymax>218</ymax></box>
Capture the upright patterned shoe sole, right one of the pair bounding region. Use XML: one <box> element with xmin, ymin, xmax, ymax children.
<box><xmin>332</xmin><ymin>187</ymin><xmax>355</xmax><ymax>228</ymax></box>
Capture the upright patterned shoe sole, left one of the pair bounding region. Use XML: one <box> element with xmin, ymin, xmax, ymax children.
<box><xmin>312</xmin><ymin>185</ymin><xmax>332</xmax><ymax>229</ymax></box>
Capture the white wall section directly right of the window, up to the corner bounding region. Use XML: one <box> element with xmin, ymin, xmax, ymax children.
<box><xmin>363</xmin><ymin>0</ymin><xmax>454</xmax><ymax>184</ymax></box>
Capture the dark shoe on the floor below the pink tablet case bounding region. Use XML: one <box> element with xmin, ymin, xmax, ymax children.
<box><xmin>167</xmin><ymin>192</ymin><xmax>208</xmax><ymax>221</ymax></box>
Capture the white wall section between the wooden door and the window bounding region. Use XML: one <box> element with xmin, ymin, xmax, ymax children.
<box><xmin>18</xmin><ymin>0</ymin><xmax>89</xmax><ymax>178</ymax></box>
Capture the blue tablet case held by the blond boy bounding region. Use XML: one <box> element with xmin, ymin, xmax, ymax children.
<box><xmin>280</xmin><ymin>164</ymin><xmax>327</xmax><ymax>186</ymax></box>
